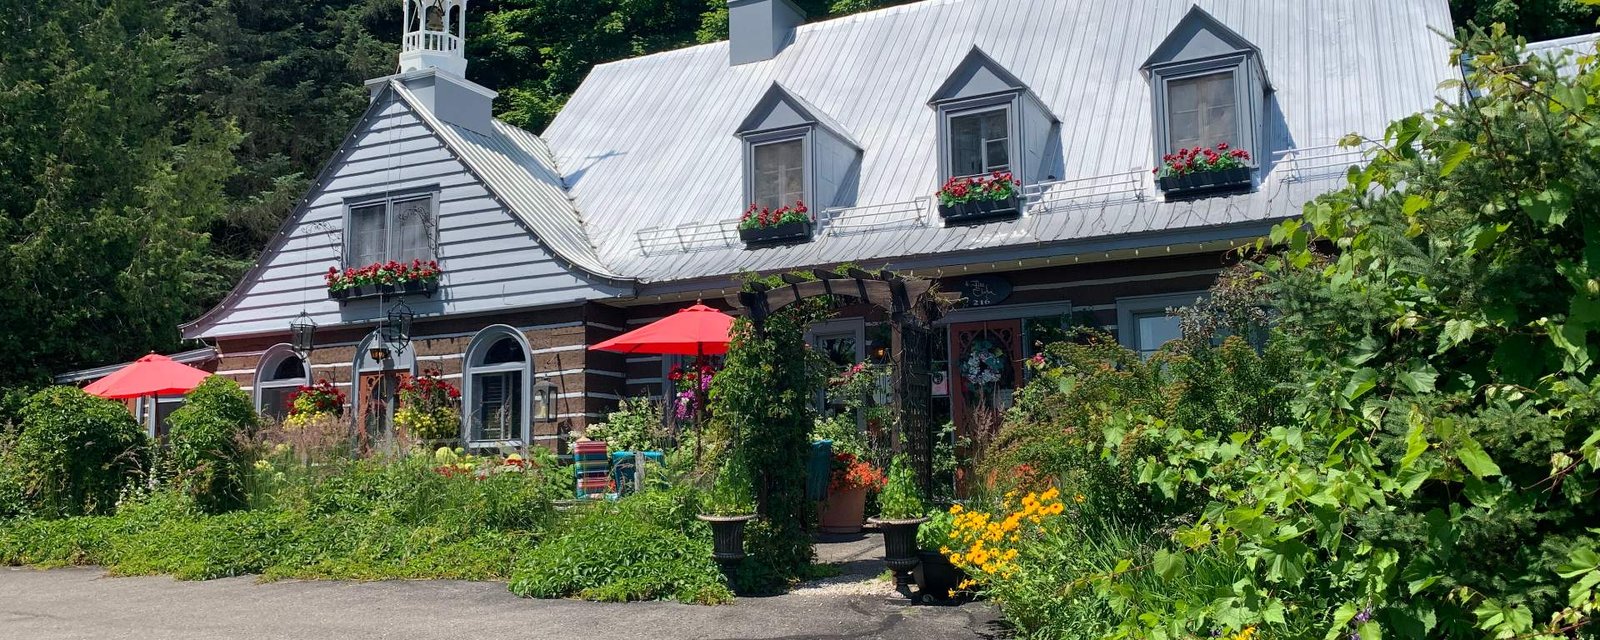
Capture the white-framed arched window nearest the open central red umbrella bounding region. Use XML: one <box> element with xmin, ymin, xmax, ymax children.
<box><xmin>462</xmin><ymin>325</ymin><xmax>533</xmax><ymax>446</ymax></box>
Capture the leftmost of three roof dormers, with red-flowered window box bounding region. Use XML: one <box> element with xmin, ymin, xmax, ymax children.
<box><xmin>730</xmin><ymin>83</ymin><xmax>861</xmax><ymax>248</ymax></box>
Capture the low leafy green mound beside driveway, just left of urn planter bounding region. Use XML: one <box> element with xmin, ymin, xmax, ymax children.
<box><xmin>510</xmin><ymin>490</ymin><xmax>733</xmax><ymax>603</ymax></box>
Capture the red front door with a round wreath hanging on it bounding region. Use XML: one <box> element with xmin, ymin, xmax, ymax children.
<box><xmin>950</xmin><ymin>320</ymin><xmax>1022</xmax><ymax>476</ymax></box>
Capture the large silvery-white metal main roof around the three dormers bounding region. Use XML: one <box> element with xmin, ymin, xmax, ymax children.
<box><xmin>544</xmin><ymin>0</ymin><xmax>1458</xmax><ymax>282</ymax></box>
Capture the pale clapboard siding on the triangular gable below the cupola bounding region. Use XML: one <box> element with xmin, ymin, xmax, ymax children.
<box><xmin>189</xmin><ymin>91</ymin><xmax>622</xmax><ymax>338</ymax></box>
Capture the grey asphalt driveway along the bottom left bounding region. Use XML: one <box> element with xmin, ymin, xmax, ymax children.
<box><xmin>0</xmin><ymin>568</ymin><xmax>1000</xmax><ymax>640</ymax></box>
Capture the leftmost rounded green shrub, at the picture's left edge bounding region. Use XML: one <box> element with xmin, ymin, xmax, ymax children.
<box><xmin>11</xmin><ymin>387</ymin><xmax>146</xmax><ymax>517</ymax></box>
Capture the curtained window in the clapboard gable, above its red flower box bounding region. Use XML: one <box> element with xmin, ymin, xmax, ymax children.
<box><xmin>347</xmin><ymin>195</ymin><xmax>435</xmax><ymax>267</ymax></box>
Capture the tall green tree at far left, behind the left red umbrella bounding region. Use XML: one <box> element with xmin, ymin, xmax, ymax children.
<box><xmin>0</xmin><ymin>0</ymin><xmax>242</xmax><ymax>386</ymax></box>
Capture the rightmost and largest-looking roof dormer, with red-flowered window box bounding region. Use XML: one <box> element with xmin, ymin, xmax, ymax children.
<box><xmin>1141</xmin><ymin>6</ymin><xmax>1272</xmax><ymax>198</ymax></box>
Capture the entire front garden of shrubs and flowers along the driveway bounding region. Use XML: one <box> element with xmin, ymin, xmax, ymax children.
<box><xmin>0</xmin><ymin>31</ymin><xmax>1600</xmax><ymax>640</ymax></box>
